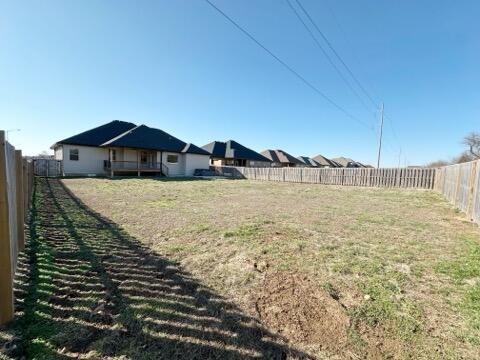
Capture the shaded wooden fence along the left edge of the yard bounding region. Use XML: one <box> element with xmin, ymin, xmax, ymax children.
<box><xmin>0</xmin><ymin>131</ymin><xmax>33</xmax><ymax>324</ymax></box>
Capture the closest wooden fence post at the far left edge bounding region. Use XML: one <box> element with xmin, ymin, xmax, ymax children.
<box><xmin>0</xmin><ymin>131</ymin><xmax>13</xmax><ymax>324</ymax></box>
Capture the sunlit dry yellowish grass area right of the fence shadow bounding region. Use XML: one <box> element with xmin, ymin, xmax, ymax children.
<box><xmin>64</xmin><ymin>179</ymin><xmax>480</xmax><ymax>358</ymax></box>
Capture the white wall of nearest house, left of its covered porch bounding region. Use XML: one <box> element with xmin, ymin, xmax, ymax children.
<box><xmin>61</xmin><ymin>145</ymin><xmax>108</xmax><ymax>176</ymax></box>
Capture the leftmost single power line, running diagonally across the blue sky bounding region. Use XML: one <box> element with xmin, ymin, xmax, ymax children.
<box><xmin>205</xmin><ymin>0</ymin><xmax>372</xmax><ymax>130</ymax></box>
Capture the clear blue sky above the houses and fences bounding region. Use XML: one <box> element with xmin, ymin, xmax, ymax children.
<box><xmin>0</xmin><ymin>0</ymin><xmax>480</xmax><ymax>166</ymax></box>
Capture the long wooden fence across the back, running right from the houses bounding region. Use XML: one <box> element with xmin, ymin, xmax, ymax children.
<box><xmin>214</xmin><ymin>166</ymin><xmax>436</xmax><ymax>189</ymax></box>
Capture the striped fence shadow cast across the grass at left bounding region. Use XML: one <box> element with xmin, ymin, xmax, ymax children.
<box><xmin>5</xmin><ymin>178</ymin><xmax>308</xmax><ymax>359</ymax></box>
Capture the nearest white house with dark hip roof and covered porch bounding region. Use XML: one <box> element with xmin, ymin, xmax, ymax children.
<box><xmin>52</xmin><ymin>120</ymin><xmax>210</xmax><ymax>176</ymax></box>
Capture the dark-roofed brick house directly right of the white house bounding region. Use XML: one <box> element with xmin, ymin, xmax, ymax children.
<box><xmin>202</xmin><ymin>140</ymin><xmax>271</xmax><ymax>167</ymax></box>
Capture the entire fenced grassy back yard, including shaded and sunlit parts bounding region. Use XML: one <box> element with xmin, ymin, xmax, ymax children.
<box><xmin>0</xmin><ymin>179</ymin><xmax>480</xmax><ymax>359</ymax></box>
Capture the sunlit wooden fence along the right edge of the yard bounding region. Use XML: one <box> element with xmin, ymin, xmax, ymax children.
<box><xmin>435</xmin><ymin>160</ymin><xmax>480</xmax><ymax>223</ymax></box>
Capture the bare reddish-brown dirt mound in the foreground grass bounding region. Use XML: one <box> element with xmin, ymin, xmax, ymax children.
<box><xmin>256</xmin><ymin>273</ymin><xmax>350</xmax><ymax>354</ymax></box>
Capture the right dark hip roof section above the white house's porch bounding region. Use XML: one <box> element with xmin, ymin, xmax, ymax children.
<box><xmin>101</xmin><ymin>125</ymin><xmax>210</xmax><ymax>155</ymax></box>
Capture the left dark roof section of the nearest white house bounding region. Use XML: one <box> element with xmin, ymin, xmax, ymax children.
<box><xmin>54</xmin><ymin>120</ymin><xmax>137</xmax><ymax>146</ymax></box>
